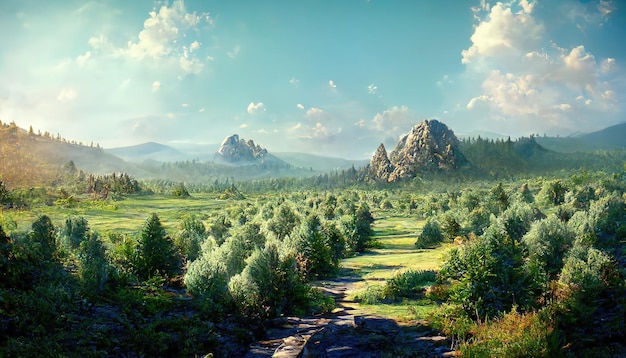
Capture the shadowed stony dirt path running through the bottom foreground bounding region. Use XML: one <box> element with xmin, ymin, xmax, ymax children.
<box><xmin>245</xmin><ymin>272</ymin><xmax>453</xmax><ymax>358</ymax></box>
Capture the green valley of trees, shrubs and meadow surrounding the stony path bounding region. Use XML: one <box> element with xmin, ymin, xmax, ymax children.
<box><xmin>0</xmin><ymin>121</ymin><xmax>626</xmax><ymax>357</ymax></box>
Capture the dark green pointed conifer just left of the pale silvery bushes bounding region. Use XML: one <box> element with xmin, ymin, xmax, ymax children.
<box><xmin>136</xmin><ymin>213</ymin><xmax>181</xmax><ymax>280</ymax></box>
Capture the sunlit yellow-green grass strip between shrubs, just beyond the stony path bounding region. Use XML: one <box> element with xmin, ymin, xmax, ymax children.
<box><xmin>342</xmin><ymin>216</ymin><xmax>451</xmax><ymax>321</ymax></box>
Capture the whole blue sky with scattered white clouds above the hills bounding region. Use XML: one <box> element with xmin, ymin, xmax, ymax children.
<box><xmin>0</xmin><ymin>0</ymin><xmax>626</xmax><ymax>159</ymax></box>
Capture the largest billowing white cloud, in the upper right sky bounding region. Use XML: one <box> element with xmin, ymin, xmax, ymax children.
<box><xmin>458</xmin><ymin>0</ymin><xmax>617</xmax><ymax>131</ymax></box>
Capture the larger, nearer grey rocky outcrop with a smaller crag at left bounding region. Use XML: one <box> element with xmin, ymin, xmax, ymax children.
<box><xmin>370</xmin><ymin>119</ymin><xmax>465</xmax><ymax>182</ymax></box>
